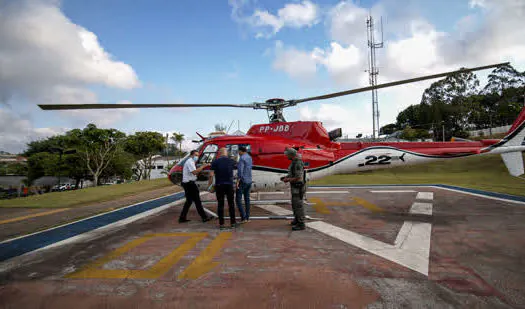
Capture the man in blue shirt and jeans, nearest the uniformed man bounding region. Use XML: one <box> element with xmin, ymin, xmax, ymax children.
<box><xmin>236</xmin><ymin>146</ymin><xmax>252</xmax><ymax>223</ymax></box>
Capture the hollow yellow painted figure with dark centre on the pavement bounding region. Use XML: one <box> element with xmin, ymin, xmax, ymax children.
<box><xmin>65</xmin><ymin>233</ymin><xmax>208</xmax><ymax>279</ymax></box>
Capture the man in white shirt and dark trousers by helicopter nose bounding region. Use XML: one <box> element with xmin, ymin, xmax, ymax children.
<box><xmin>179</xmin><ymin>150</ymin><xmax>211</xmax><ymax>223</ymax></box>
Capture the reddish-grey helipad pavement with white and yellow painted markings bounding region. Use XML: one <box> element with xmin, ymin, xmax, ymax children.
<box><xmin>0</xmin><ymin>187</ymin><xmax>525</xmax><ymax>309</ymax></box>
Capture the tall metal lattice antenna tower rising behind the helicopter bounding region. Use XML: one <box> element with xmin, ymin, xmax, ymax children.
<box><xmin>366</xmin><ymin>15</ymin><xmax>383</xmax><ymax>138</ymax></box>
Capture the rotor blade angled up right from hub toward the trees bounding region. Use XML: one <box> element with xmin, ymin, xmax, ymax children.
<box><xmin>290</xmin><ymin>62</ymin><xmax>509</xmax><ymax>105</ymax></box>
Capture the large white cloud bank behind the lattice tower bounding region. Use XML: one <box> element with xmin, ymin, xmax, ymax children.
<box><xmin>275</xmin><ymin>0</ymin><xmax>525</xmax><ymax>134</ymax></box>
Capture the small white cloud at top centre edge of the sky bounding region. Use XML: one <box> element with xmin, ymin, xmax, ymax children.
<box><xmin>229</xmin><ymin>0</ymin><xmax>319</xmax><ymax>38</ymax></box>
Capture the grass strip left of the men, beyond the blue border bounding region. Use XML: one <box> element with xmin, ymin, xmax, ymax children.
<box><xmin>0</xmin><ymin>178</ymin><xmax>175</xmax><ymax>208</ymax></box>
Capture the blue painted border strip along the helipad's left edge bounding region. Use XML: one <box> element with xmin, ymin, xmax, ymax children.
<box><xmin>0</xmin><ymin>192</ymin><xmax>184</xmax><ymax>262</ymax></box>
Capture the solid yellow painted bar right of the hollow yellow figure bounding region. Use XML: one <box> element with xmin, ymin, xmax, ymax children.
<box><xmin>179</xmin><ymin>232</ymin><xmax>232</xmax><ymax>279</ymax></box>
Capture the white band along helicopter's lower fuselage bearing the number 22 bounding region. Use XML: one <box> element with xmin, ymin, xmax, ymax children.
<box><xmin>198</xmin><ymin>147</ymin><xmax>474</xmax><ymax>192</ymax></box>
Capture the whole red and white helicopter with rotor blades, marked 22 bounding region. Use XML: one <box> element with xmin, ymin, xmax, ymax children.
<box><xmin>39</xmin><ymin>63</ymin><xmax>525</xmax><ymax>192</ymax></box>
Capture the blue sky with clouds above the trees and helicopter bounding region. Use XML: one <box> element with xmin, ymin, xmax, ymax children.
<box><xmin>0</xmin><ymin>0</ymin><xmax>525</xmax><ymax>153</ymax></box>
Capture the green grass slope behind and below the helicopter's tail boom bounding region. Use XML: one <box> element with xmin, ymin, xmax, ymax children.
<box><xmin>311</xmin><ymin>155</ymin><xmax>525</xmax><ymax>196</ymax></box>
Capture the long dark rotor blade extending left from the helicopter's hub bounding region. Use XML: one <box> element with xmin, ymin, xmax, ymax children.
<box><xmin>38</xmin><ymin>103</ymin><xmax>255</xmax><ymax>110</ymax></box>
